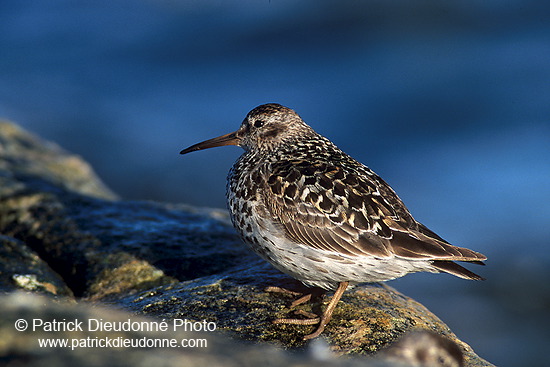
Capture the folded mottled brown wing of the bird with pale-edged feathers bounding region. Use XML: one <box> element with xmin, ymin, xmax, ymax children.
<box><xmin>264</xmin><ymin>161</ymin><xmax>485</xmax><ymax>261</ymax></box>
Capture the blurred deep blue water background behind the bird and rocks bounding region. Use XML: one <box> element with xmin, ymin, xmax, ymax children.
<box><xmin>0</xmin><ymin>0</ymin><xmax>550</xmax><ymax>366</ymax></box>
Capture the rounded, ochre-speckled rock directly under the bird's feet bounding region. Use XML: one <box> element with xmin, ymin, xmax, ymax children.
<box><xmin>115</xmin><ymin>261</ymin><xmax>490</xmax><ymax>366</ymax></box>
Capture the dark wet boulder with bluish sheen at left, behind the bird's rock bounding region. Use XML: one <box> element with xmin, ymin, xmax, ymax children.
<box><xmin>0</xmin><ymin>123</ymin><xmax>249</xmax><ymax>299</ymax></box>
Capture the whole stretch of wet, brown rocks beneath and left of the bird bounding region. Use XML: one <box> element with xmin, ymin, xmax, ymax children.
<box><xmin>0</xmin><ymin>122</ymin><xmax>491</xmax><ymax>366</ymax></box>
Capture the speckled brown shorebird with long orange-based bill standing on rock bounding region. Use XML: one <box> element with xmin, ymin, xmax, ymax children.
<box><xmin>180</xmin><ymin>103</ymin><xmax>487</xmax><ymax>340</ymax></box>
